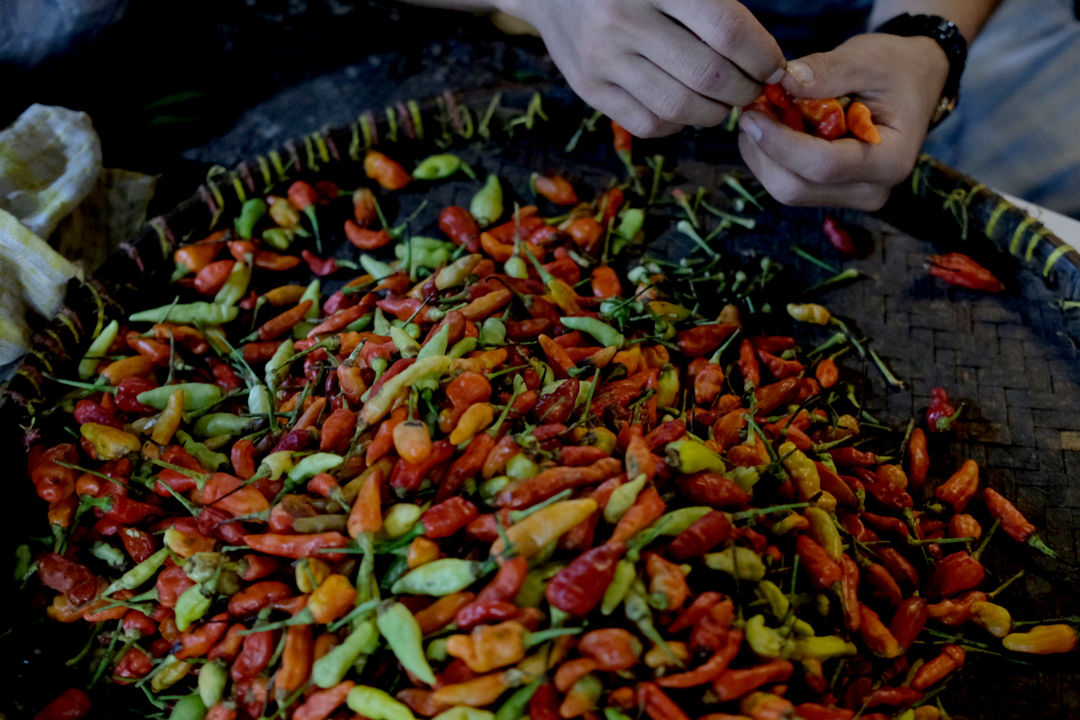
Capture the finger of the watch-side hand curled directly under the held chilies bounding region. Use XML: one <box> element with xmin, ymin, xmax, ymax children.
<box><xmin>739</xmin><ymin>112</ymin><xmax>907</xmax><ymax>185</ymax></box>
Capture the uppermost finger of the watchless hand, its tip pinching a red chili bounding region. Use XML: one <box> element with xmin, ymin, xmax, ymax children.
<box><xmin>656</xmin><ymin>0</ymin><xmax>784</xmax><ymax>83</ymax></box>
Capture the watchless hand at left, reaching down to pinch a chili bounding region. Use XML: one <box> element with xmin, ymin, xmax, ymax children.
<box><xmin>500</xmin><ymin>0</ymin><xmax>784</xmax><ymax>137</ymax></box>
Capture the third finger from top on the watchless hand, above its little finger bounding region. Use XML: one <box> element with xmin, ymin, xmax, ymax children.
<box><xmin>613</xmin><ymin>55</ymin><xmax>731</xmax><ymax>127</ymax></box>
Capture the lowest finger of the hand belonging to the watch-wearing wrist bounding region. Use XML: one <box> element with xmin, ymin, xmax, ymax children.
<box><xmin>739</xmin><ymin>133</ymin><xmax>889</xmax><ymax>210</ymax></box>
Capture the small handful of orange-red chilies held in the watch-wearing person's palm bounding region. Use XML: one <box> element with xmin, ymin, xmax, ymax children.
<box><xmin>743</xmin><ymin>84</ymin><xmax>881</xmax><ymax>145</ymax></box>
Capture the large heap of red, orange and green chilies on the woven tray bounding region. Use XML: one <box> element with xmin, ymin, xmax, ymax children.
<box><xmin>28</xmin><ymin>124</ymin><xmax>1077</xmax><ymax>720</ymax></box>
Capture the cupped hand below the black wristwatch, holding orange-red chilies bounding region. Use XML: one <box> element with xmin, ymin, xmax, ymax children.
<box><xmin>739</xmin><ymin>33</ymin><xmax>948</xmax><ymax>210</ymax></box>
